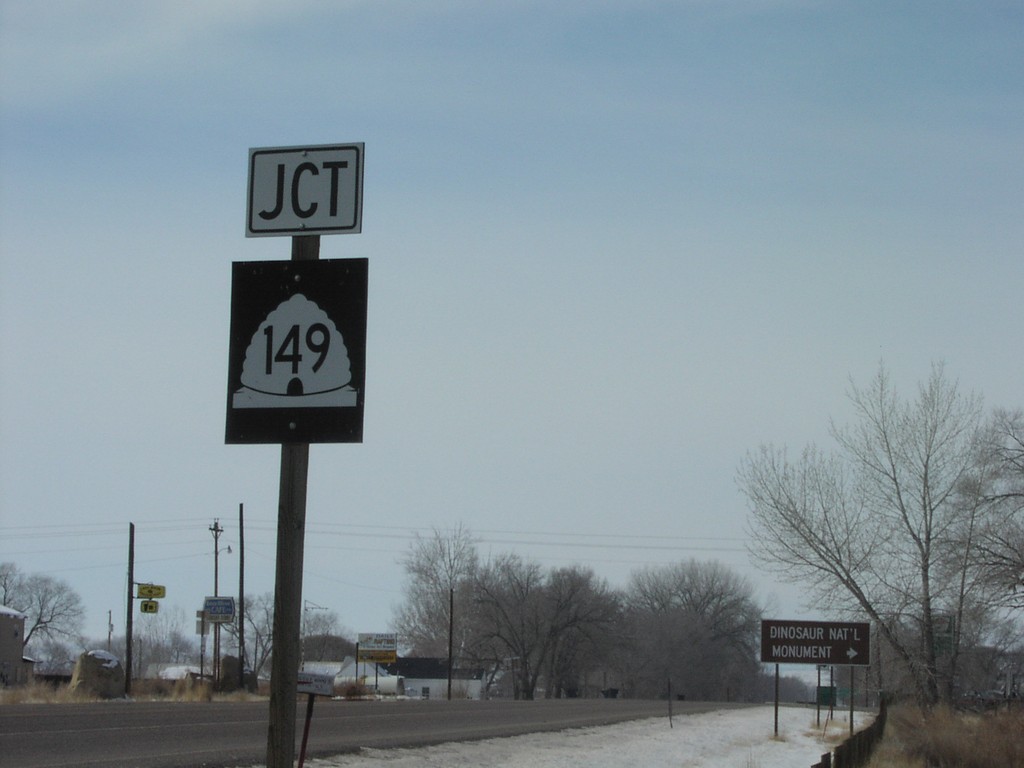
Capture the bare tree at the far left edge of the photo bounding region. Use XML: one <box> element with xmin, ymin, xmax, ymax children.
<box><xmin>0</xmin><ymin>562</ymin><xmax>84</xmax><ymax>645</ymax></box>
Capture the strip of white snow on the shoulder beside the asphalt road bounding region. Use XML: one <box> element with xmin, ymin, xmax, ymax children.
<box><xmin>306</xmin><ymin>705</ymin><xmax>874</xmax><ymax>768</ymax></box>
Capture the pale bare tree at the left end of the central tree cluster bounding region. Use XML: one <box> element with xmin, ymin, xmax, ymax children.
<box><xmin>394</xmin><ymin>523</ymin><xmax>477</xmax><ymax>656</ymax></box>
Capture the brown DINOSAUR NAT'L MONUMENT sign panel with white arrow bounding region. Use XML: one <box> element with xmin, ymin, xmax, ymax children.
<box><xmin>761</xmin><ymin>618</ymin><xmax>871</xmax><ymax>667</ymax></box>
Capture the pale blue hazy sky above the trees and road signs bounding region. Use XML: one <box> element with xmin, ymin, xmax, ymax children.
<box><xmin>0</xmin><ymin>0</ymin><xmax>1024</xmax><ymax>663</ymax></box>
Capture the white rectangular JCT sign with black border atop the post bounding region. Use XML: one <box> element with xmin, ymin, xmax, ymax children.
<box><xmin>246</xmin><ymin>142</ymin><xmax>364</xmax><ymax>238</ymax></box>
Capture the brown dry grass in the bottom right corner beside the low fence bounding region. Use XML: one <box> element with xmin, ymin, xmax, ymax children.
<box><xmin>868</xmin><ymin>707</ymin><xmax>1024</xmax><ymax>768</ymax></box>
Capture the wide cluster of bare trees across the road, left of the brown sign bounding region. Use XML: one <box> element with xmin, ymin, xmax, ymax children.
<box><xmin>395</xmin><ymin>525</ymin><xmax>762</xmax><ymax>699</ymax></box>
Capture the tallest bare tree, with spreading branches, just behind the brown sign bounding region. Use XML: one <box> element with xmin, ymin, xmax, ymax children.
<box><xmin>738</xmin><ymin>366</ymin><xmax>984</xmax><ymax>702</ymax></box>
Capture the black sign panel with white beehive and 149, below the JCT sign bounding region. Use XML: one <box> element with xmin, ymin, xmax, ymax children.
<box><xmin>225</xmin><ymin>259</ymin><xmax>368</xmax><ymax>443</ymax></box>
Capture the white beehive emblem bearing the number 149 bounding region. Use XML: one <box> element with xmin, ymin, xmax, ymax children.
<box><xmin>231</xmin><ymin>294</ymin><xmax>357</xmax><ymax>409</ymax></box>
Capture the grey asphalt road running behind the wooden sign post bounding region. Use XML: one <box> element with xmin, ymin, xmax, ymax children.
<box><xmin>0</xmin><ymin>696</ymin><xmax>728</xmax><ymax>768</ymax></box>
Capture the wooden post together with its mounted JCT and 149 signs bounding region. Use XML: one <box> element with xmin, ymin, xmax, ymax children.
<box><xmin>233</xmin><ymin>143</ymin><xmax>367</xmax><ymax>768</ymax></box>
